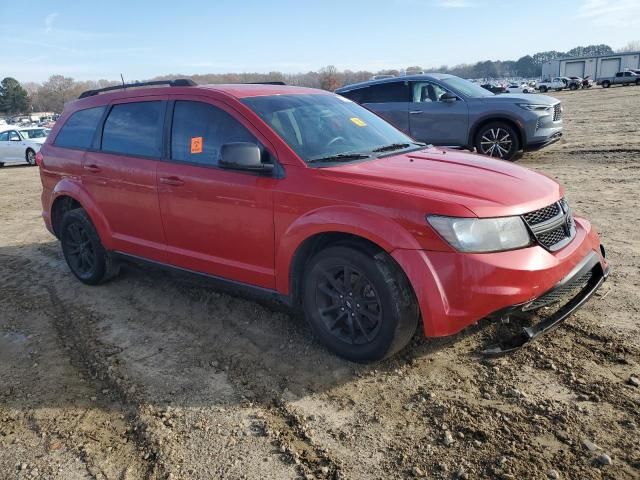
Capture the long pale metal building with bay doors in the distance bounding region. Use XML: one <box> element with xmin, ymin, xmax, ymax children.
<box><xmin>542</xmin><ymin>52</ymin><xmax>640</xmax><ymax>80</ymax></box>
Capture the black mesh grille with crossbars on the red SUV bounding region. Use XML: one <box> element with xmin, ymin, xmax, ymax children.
<box><xmin>522</xmin><ymin>198</ymin><xmax>576</xmax><ymax>251</ymax></box>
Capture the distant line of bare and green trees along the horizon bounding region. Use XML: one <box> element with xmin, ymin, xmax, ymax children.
<box><xmin>0</xmin><ymin>41</ymin><xmax>638</xmax><ymax>115</ymax></box>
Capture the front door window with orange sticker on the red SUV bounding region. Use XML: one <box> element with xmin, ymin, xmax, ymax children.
<box><xmin>171</xmin><ymin>101</ymin><xmax>259</xmax><ymax>166</ymax></box>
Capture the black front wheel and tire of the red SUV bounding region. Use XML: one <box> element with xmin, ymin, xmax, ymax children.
<box><xmin>302</xmin><ymin>246</ymin><xmax>419</xmax><ymax>362</ymax></box>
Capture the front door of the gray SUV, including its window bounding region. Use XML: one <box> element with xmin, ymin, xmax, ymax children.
<box><xmin>409</xmin><ymin>81</ymin><xmax>469</xmax><ymax>146</ymax></box>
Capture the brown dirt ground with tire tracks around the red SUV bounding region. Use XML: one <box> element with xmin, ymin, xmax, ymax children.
<box><xmin>0</xmin><ymin>87</ymin><xmax>640</xmax><ymax>479</ymax></box>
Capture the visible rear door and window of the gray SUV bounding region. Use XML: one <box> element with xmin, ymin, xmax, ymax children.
<box><xmin>361</xmin><ymin>80</ymin><xmax>409</xmax><ymax>134</ymax></box>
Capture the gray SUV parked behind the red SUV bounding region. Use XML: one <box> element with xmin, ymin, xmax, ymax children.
<box><xmin>336</xmin><ymin>73</ymin><xmax>562</xmax><ymax>160</ymax></box>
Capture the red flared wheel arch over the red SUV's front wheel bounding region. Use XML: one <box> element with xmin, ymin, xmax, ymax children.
<box><xmin>275</xmin><ymin>206</ymin><xmax>420</xmax><ymax>295</ymax></box>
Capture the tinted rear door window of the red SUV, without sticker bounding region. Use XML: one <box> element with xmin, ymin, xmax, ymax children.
<box><xmin>102</xmin><ymin>101</ymin><xmax>164</xmax><ymax>157</ymax></box>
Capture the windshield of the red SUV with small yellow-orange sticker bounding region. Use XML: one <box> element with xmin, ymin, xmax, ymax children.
<box><xmin>242</xmin><ymin>94</ymin><xmax>423</xmax><ymax>162</ymax></box>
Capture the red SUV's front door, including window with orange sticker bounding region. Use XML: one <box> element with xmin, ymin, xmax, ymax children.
<box><xmin>157</xmin><ymin>97</ymin><xmax>278</xmax><ymax>289</ymax></box>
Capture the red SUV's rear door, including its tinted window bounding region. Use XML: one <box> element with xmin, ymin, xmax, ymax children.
<box><xmin>82</xmin><ymin>96</ymin><xmax>167</xmax><ymax>262</ymax></box>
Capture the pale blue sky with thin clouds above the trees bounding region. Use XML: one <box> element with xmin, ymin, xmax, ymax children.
<box><xmin>0</xmin><ymin>0</ymin><xmax>640</xmax><ymax>81</ymax></box>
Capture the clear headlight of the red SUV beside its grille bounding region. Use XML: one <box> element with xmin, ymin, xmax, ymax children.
<box><xmin>427</xmin><ymin>215</ymin><xmax>531</xmax><ymax>253</ymax></box>
